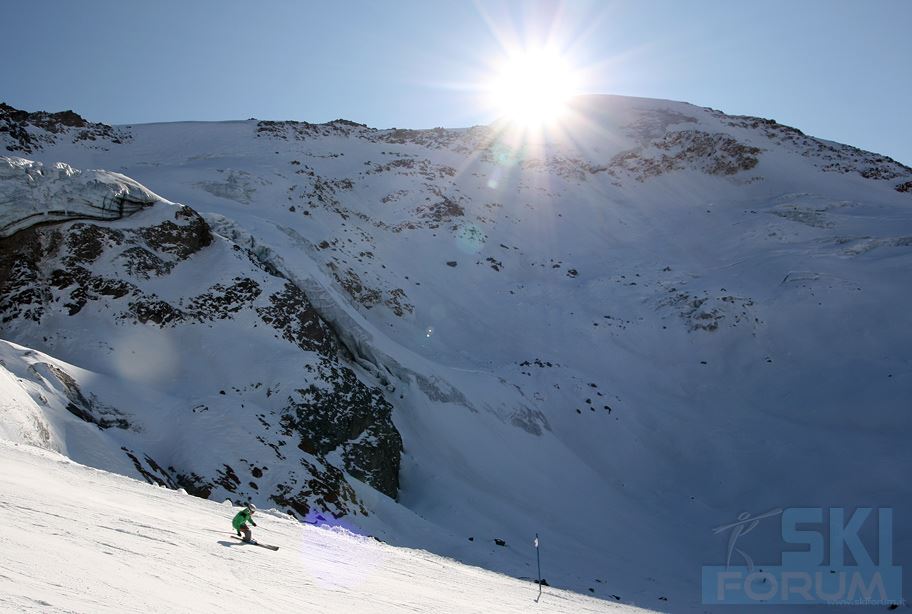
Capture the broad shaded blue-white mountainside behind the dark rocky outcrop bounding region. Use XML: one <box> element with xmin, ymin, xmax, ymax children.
<box><xmin>3</xmin><ymin>97</ymin><xmax>912</xmax><ymax>610</ymax></box>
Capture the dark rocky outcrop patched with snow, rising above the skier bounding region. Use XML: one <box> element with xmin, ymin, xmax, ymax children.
<box><xmin>0</xmin><ymin>159</ymin><xmax>402</xmax><ymax>517</ymax></box>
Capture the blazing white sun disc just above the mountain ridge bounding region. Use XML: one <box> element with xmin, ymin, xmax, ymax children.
<box><xmin>486</xmin><ymin>48</ymin><xmax>577</xmax><ymax>128</ymax></box>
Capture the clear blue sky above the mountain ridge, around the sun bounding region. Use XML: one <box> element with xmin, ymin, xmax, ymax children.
<box><xmin>0</xmin><ymin>0</ymin><xmax>912</xmax><ymax>165</ymax></box>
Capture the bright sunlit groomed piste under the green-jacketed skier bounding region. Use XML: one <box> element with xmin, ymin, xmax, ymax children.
<box><xmin>0</xmin><ymin>440</ymin><xmax>645</xmax><ymax>614</ymax></box>
